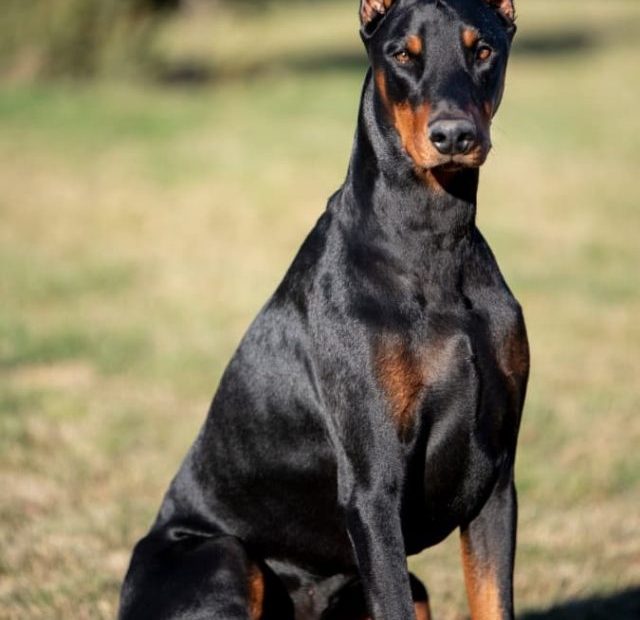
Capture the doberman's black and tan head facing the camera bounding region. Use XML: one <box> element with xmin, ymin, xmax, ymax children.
<box><xmin>360</xmin><ymin>0</ymin><xmax>515</xmax><ymax>171</ymax></box>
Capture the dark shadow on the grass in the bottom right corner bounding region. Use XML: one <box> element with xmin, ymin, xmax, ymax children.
<box><xmin>519</xmin><ymin>587</ymin><xmax>640</xmax><ymax>620</ymax></box>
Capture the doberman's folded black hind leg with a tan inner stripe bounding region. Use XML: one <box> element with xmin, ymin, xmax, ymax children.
<box><xmin>119</xmin><ymin>528</ymin><xmax>293</xmax><ymax>620</ymax></box>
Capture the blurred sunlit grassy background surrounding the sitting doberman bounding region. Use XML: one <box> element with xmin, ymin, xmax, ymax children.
<box><xmin>0</xmin><ymin>0</ymin><xmax>640</xmax><ymax>620</ymax></box>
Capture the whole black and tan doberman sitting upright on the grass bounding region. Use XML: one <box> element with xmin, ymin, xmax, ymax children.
<box><xmin>120</xmin><ymin>0</ymin><xmax>529</xmax><ymax>620</ymax></box>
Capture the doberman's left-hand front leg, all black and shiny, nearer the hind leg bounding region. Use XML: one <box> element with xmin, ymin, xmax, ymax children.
<box><xmin>338</xmin><ymin>446</ymin><xmax>415</xmax><ymax>620</ymax></box>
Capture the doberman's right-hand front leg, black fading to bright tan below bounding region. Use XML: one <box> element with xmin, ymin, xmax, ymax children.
<box><xmin>460</xmin><ymin>468</ymin><xmax>517</xmax><ymax>620</ymax></box>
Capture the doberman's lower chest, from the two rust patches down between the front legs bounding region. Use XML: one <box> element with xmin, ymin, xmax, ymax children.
<box><xmin>376</xmin><ymin>294</ymin><xmax>528</xmax><ymax>536</ymax></box>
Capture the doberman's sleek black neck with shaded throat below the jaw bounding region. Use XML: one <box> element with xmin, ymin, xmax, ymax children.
<box><xmin>342</xmin><ymin>72</ymin><xmax>478</xmax><ymax>247</ymax></box>
